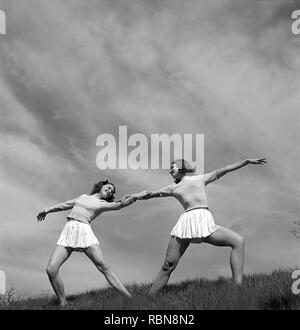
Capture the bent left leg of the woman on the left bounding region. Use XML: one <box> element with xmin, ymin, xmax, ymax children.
<box><xmin>46</xmin><ymin>245</ymin><xmax>72</xmax><ymax>306</ymax></box>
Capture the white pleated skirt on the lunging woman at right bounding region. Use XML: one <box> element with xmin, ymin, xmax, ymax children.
<box><xmin>170</xmin><ymin>208</ymin><xmax>220</xmax><ymax>243</ymax></box>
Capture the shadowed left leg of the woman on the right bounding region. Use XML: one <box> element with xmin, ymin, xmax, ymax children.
<box><xmin>149</xmin><ymin>236</ymin><xmax>190</xmax><ymax>295</ymax></box>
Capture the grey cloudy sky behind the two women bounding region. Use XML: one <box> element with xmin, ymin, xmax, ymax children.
<box><xmin>0</xmin><ymin>0</ymin><xmax>300</xmax><ymax>295</ymax></box>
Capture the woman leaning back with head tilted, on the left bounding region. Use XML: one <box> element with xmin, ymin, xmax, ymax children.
<box><xmin>37</xmin><ymin>180</ymin><xmax>146</xmax><ymax>306</ymax></box>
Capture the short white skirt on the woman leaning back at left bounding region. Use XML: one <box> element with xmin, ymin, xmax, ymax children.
<box><xmin>56</xmin><ymin>220</ymin><xmax>99</xmax><ymax>249</ymax></box>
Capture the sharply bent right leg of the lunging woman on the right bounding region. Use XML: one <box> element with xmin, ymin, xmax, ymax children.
<box><xmin>203</xmin><ymin>227</ymin><xmax>245</xmax><ymax>284</ymax></box>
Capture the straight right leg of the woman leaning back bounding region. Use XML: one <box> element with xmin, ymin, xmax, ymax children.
<box><xmin>85</xmin><ymin>244</ymin><xmax>131</xmax><ymax>297</ymax></box>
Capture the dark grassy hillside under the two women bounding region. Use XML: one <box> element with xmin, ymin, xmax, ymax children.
<box><xmin>0</xmin><ymin>270</ymin><xmax>300</xmax><ymax>310</ymax></box>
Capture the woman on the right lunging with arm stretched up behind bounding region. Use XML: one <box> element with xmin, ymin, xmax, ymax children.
<box><xmin>139</xmin><ymin>158</ymin><xmax>267</xmax><ymax>295</ymax></box>
